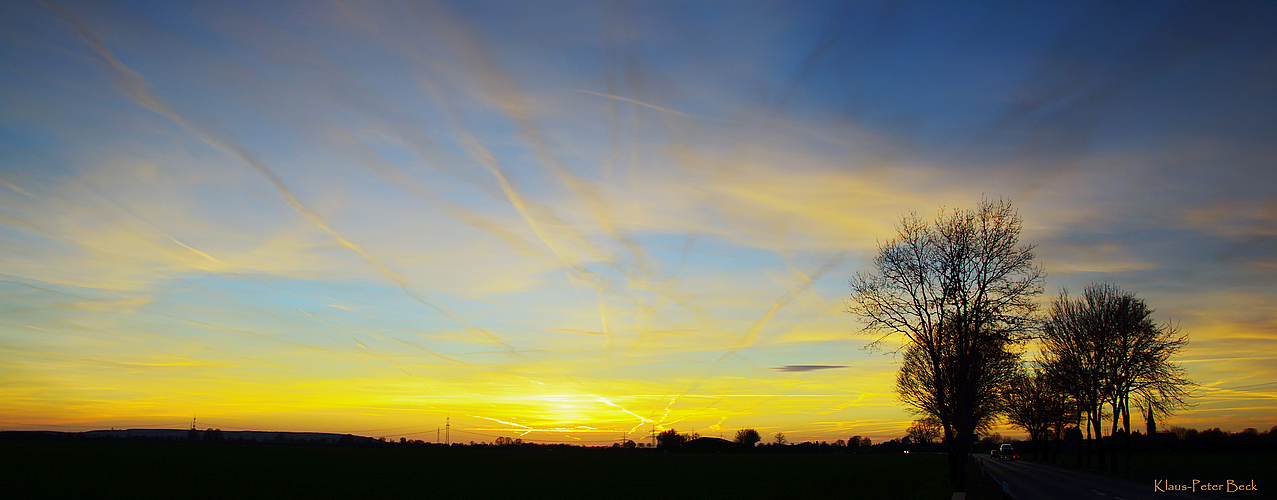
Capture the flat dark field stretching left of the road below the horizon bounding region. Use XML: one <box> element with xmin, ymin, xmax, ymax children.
<box><xmin>0</xmin><ymin>440</ymin><xmax>951</xmax><ymax>499</ymax></box>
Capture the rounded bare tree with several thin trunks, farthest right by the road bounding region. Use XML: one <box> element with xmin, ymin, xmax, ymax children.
<box><xmin>1042</xmin><ymin>283</ymin><xmax>1194</xmax><ymax>473</ymax></box>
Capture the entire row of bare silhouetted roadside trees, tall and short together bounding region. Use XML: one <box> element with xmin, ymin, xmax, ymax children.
<box><xmin>848</xmin><ymin>199</ymin><xmax>1191</xmax><ymax>491</ymax></box>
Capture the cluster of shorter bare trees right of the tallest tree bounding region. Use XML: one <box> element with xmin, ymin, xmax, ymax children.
<box><xmin>1006</xmin><ymin>283</ymin><xmax>1193</xmax><ymax>473</ymax></box>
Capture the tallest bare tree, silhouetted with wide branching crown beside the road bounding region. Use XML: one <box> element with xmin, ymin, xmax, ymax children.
<box><xmin>847</xmin><ymin>199</ymin><xmax>1045</xmax><ymax>491</ymax></box>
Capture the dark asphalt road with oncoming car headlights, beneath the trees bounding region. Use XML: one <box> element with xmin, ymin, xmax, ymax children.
<box><xmin>976</xmin><ymin>455</ymin><xmax>1225</xmax><ymax>500</ymax></box>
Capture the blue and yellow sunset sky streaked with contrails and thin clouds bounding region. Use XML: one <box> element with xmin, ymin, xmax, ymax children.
<box><xmin>0</xmin><ymin>0</ymin><xmax>1277</xmax><ymax>445</ymax></box>
